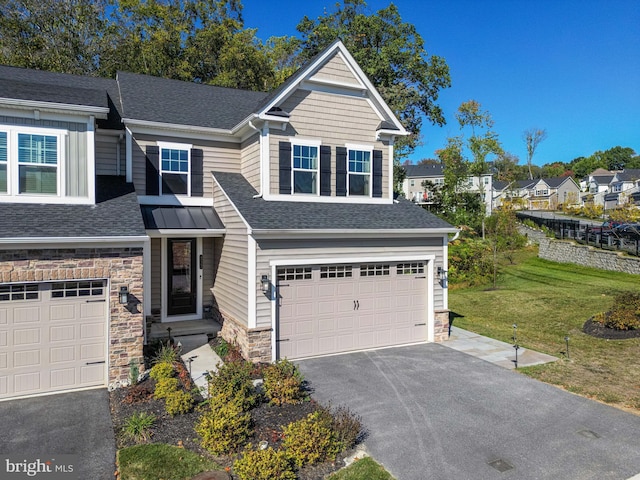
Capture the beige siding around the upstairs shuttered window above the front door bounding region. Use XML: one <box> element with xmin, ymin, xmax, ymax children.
<box><xmin>133</xmin><ymin>135</ymin><xmax>240</xmax><ymax>197</ymax></box>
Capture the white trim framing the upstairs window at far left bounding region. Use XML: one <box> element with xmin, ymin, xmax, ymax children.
<box><xmin>0</xmin><ymin>125</ymin><xmax>65</xmax><ymax>198</ymax></box>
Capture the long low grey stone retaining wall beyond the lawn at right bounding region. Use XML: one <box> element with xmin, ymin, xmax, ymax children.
<box><xmin>538</xmin><ymin>237</ymin><xmax>640</xmax><ymax>275</ymax></box>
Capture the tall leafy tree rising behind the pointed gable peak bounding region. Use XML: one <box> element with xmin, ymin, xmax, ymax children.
<box><xmin>297</xmin><ymin>0</ymin><xmax>451</xmax><ymax>161</ymax></box>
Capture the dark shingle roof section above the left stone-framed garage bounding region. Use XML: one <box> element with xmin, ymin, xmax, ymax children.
<box><xmin>0</xmin><ymin>176</ymin><xmax>146</xmax><ymax>238</ymax></box>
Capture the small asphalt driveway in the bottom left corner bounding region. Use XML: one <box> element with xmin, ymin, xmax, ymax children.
<box><xmin>0</xmin><ymin>389</ymin><xmax>116</xmax><ymax>480</ymax></box>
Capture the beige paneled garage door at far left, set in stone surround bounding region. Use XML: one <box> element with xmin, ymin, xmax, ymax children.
<box><xmin>0</xmin><ymin>280</ymin><xmax>108</xmax><ymax>399</ymax></box>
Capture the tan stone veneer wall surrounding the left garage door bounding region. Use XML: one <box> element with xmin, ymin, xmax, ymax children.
<box><xmin>0</xmin><ymin>247</ymin><xmax>144</xmax><ymax>387</ymax></box>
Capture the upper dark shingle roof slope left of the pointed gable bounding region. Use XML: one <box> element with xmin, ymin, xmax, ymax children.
<box><xmin>117</xmin><ymin>72</ymin><xmax>267</xmax><ymax>130</ymax></box>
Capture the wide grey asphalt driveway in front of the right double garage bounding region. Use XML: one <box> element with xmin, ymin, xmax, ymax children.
<box><xmin>298</xmin><ymin>344</ymin><xmax>640</xmax><ymax>480</ymax></box>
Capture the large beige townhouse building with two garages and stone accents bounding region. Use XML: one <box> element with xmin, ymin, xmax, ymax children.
<box><xmin>0</xmin><ymin>42</ymin><xmax>455</xmax><ymax>399</ymax></box>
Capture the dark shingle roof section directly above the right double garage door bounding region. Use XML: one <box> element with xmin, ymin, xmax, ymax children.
<box><xmin>212</xmin><ymin>172</ymin><xmax>454</xmax><ymax>231</ymax></box>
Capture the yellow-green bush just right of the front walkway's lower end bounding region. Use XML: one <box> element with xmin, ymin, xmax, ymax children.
<box><xmin>209</xmin><ymin>360</ymin><xmax>258</xmax><ymax>412</ymax></box>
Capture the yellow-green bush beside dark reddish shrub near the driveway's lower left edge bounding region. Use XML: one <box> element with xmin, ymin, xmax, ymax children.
<box><xmin>282</xmin><ymin>411</ymin><xmax>343</xmax><ymax>468</ymax></box>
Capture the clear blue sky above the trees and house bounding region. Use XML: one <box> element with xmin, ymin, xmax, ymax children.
<box><xmin>243</xmin><ymin>0</ymin><xmax>640</xmax><ymax>165</ymax></box>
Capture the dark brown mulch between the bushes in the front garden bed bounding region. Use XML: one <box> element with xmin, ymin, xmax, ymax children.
<box><xmin>110</xmin><ymin>368</ymin><xmax>344</xmax><ymax>480</ymax></box>
